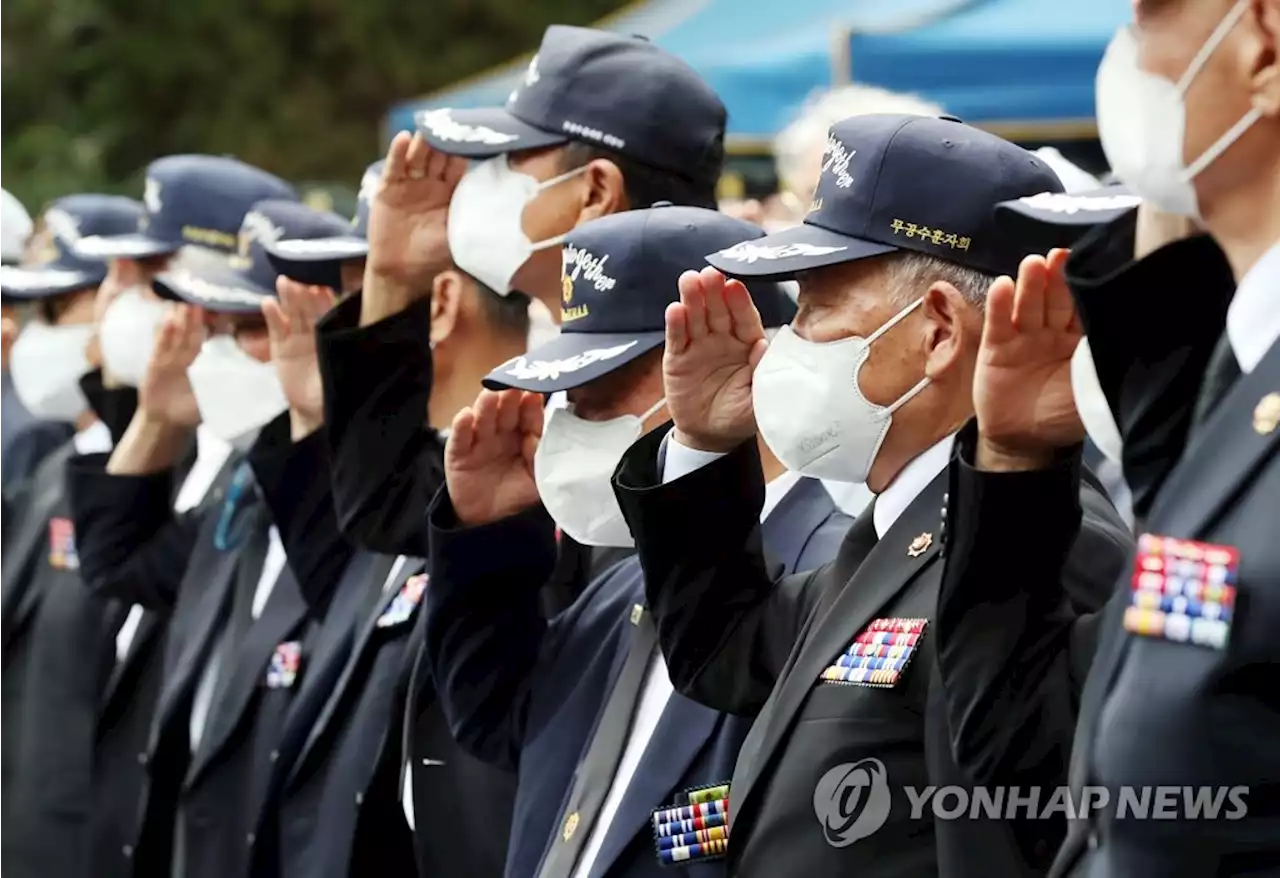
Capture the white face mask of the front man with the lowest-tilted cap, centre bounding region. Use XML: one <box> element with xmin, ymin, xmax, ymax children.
<box><xmin>534</xmin><ymin>399</ymin><xmax>666</xmax><ymax>548</ymax></box>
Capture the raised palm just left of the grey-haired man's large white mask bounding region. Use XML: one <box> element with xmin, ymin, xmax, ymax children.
<box><xmin>662</xmin><ymin>269</ymin><xmax>768</xmax><ymax>452</ymax></box>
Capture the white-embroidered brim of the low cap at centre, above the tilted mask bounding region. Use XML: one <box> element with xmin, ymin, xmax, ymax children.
<box><xmin>483</xmin><ymin>330</ymin><xmax>666</xmax><ymax>393</ymax></box>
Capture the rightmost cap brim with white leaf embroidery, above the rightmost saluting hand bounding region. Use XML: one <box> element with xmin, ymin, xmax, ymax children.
<box><xmin>996</xmin><ymin>184</ymin><xmax>1142</xmax><ymax>250</ymax></box>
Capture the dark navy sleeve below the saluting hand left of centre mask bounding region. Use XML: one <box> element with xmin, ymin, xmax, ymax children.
<box><xmin>425</xmin><ymin>490</ymin><xmax>559</xmax><ymax>769</ymax></box>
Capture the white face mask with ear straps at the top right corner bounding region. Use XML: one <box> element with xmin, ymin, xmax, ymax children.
<box><xmin>1097</xmin><ymin>0</ymin><xmax>1262</xmax><ymax>219</ymax></box>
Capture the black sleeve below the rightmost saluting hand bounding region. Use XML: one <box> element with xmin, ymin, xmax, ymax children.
<box><xmin>937</xmin><ymin>424</ymin><xmax>1132</xmax><ymax>788</ymax></box>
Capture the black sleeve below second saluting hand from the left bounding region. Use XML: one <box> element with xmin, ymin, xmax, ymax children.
<box><xmin>248</xmin><ymin>413</ymin><xmax>353</xmax><ymax>619</ymax></box>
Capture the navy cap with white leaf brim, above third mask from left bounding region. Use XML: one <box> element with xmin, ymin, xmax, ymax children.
<box><xmin>152</xmin><ymin>201</ymin><xmax>349</xmax><ymax>314</ymax></box>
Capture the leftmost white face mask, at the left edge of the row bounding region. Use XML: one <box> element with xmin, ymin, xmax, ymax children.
<box><xmin>9</xmin><ymin>321</ymin><xmax>93</xmax><ymax>422</ymax></box>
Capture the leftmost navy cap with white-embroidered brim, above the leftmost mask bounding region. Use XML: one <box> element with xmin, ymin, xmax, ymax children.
<box><xmin>0</xmin><ymin>195</ymin><xmax>145</xmax><ymax>299</ymax></box>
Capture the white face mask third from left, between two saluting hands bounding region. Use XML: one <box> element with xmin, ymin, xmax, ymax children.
<box><xmin>187</xmin><ymin>335</ymin><xmax>289</xmax><ymax>449</ymax></box>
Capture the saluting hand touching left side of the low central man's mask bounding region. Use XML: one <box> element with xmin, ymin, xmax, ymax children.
<box><xmin>444</xmin><ymin>390</ymin><xmax>543</xmax><ymax>527</ymax></box>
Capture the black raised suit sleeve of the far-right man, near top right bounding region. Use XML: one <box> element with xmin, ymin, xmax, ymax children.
<box><xmin>1068</xmin><ymin>216</ymin><xmax>1235</xmax><ymax>521</ymax></box>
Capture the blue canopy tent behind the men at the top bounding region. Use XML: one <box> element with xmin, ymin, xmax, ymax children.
<box><xmin>387</xmin><ymin>0</ymin><xmax>1128</xmax><ymax>151</ymax></box>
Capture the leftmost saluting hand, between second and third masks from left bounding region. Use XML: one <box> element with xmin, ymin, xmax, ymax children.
<box><xmin>138</xmin><ymin>305</ymin><xmax>205</xmax><ymax>429</ymax></box>
